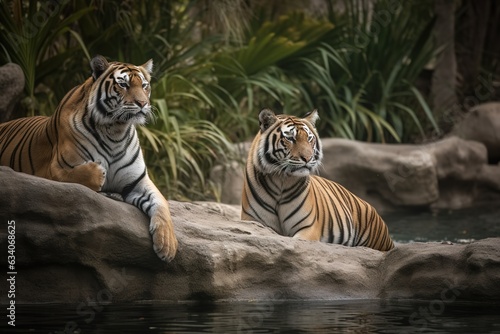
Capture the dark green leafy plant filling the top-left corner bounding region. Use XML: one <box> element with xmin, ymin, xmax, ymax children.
<box><xmin>0</xmin><ymin>0</ymin><xmax>92</xmax><ymax>114</ymax></box>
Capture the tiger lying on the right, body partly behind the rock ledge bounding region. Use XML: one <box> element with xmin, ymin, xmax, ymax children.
<box><xmin>241</xmin><ymin>109</ymin><xmax>394</xmax><ymax>251</ymax></box>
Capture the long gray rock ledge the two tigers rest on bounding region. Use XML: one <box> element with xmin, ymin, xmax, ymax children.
<box><xmin>0</xmin><ymin>167</ymin><xmax>500</xmax><ymax>305</ymax></box>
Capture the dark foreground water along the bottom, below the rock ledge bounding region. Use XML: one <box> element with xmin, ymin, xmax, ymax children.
<box><xmin>0</xmin><ymin>300</ymin><xmax>500</xmax><ymax>334</ymax></box>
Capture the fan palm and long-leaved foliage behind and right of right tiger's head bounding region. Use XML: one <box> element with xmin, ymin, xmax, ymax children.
<box><xmin>210</xmin><ymin>0</ymin><xmax>437</xmax><ymax>142</ymax></box>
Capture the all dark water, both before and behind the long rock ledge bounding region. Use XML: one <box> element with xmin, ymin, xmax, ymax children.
<box><xmin>0</xmin><ymin>208</ymin><xmax>500</xmax><ymax>334</ymax></box>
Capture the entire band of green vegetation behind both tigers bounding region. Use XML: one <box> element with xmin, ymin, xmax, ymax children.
<box><xmin>0</xmin><ymin>0</ymin><xmax>496</xmax><ymax>200</ymax></box>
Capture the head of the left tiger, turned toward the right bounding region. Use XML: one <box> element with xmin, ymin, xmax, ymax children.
<box><xmin>89</xmin><ymin>56</ymin><xmax>153</xmax><ymax>126</ymax></box>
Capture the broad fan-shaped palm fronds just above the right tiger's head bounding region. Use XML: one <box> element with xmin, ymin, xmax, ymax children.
<box><xmin>209</xmin><ymin>13</ymin><xmax>333</xmax><ymax>140</ymax></box>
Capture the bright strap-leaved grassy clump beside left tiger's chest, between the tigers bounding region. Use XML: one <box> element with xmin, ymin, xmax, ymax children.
<box><xmin>139</xmin><ymin>99</ymin><xmax>232</xmax><ymax>200</ymax></box>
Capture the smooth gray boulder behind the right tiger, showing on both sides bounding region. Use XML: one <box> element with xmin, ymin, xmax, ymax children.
<box><xmin>212</xmin><ymin>136</ymin><xmax>500</xmax><ymax>212</ymax></box>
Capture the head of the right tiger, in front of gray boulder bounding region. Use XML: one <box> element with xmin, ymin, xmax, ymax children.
<box><xmin>254</xmin><ymin>109</ymin><xmax>323</xmax><ymax>177</ymax></box>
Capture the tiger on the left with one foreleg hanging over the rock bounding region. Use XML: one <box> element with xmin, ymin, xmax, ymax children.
<box><xmin>0</xmin><ymin>56</ymin><xmax>177</xmax><ymax>261</ymax></box>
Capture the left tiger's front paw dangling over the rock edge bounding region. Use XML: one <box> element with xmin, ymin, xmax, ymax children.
<box><xmin>149</xmin><ymin>217</ymin><xmax>178</xmax><ymax>262</ymax></box>
